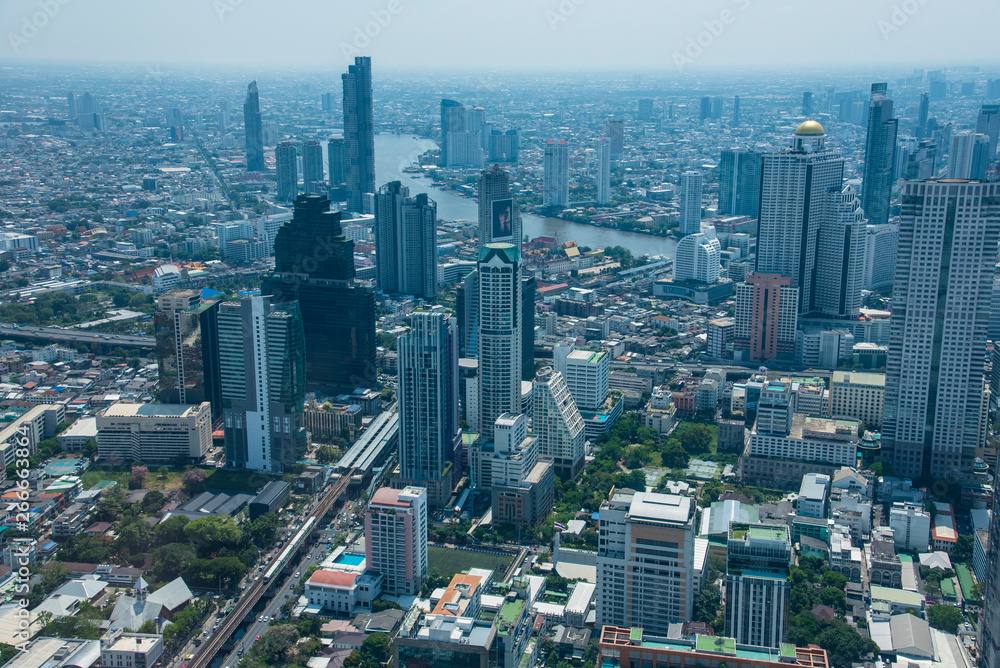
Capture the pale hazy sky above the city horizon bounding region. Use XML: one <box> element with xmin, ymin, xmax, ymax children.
<box><xmin>0</xmin><ymin>0</ymin><xmax>1000</xmax><ymax>73</ymax></box>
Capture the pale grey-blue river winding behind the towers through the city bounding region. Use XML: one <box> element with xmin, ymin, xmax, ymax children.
<box><xmin>360</xmin><ymin>135</ymin><xmax>677</xmax><ymax>258</ymax></box>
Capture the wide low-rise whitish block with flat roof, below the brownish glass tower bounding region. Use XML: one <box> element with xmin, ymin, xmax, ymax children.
<box><xmin>97</xmin><ymin>401</ymin><xmax>212</xmax><ymax>465</ymax></box>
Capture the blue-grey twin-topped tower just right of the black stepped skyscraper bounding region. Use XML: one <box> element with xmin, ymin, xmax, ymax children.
<box><xmin>375</xmin><ymin>181</ymin><xmax>437</xmax><ymax>300</ymax></box>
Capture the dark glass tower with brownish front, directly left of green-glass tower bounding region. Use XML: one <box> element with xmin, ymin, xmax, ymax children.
<box><xmin>153</xmin><ymin>290</ymin><xmax>222</xmax><ymax>418</ymax></box>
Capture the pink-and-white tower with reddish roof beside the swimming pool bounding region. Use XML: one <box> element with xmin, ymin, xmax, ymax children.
<box><xmin>365</xmin><ymin>487</ymin><xmax>427</xmax><ymax>596</ymax></box>
